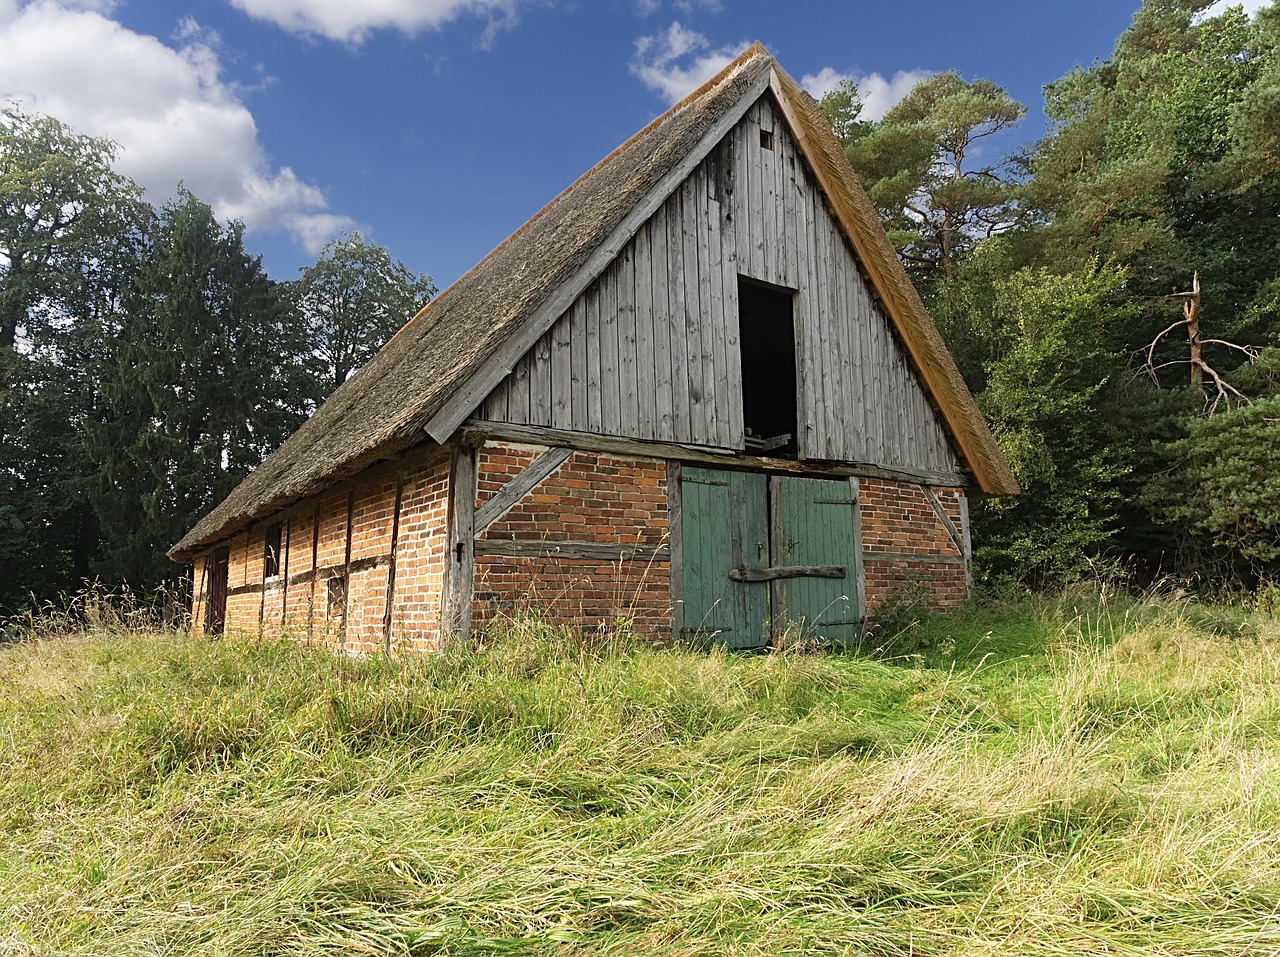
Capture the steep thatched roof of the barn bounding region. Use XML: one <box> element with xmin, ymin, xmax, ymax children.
<box><xmin>169</xmin><ymin>44</ymin><xmax>1018</xmax><ymax>562</ymax></box>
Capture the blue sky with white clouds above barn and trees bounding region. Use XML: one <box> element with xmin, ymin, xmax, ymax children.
<box><xmin>0</xmin><ymin>0</ymin><xmax>1266</xmax><ymax>289</ymax></box>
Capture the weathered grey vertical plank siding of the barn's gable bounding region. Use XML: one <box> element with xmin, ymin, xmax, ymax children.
<box><xmin>476</xmin><ymin>95</ymin><xmax>960</xmax><ymax>472</ymax></box>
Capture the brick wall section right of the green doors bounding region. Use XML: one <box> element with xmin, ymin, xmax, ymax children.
<box><xmin>859</xmin><ymin>479</ymin><xmax>968</xmax><ymax>613</ymax></box>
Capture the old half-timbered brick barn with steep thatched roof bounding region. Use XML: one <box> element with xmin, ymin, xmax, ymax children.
<box><xmin>169</xmin><ymin>45</ymin><xmax>1016</xmax><ymax>653</ymax></box>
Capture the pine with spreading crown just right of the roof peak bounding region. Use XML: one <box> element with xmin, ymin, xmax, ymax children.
<box><xmin>824</xmin><ymin>70</ymin><xmax>1027</xmax><ymax>293</ymax></box>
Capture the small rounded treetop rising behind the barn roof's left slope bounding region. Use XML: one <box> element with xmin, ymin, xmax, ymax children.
<box><xmin>294</xmin><ymin>233</ymin><xmax>436</xmax><ymax>398</ymax></box>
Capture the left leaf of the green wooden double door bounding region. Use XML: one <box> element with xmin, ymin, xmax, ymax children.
<box><xmin>680</xmin><ymin>467</ymin><xmax>771</xmax><ymax>649</ymax></box>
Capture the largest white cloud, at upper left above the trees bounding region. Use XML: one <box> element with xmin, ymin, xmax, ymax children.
<box><xmin>0</xmin><ymin>0</ymin><xmax>355</xmax><ymax>253</ymax></box>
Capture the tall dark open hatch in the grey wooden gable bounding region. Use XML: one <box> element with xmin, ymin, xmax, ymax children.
<box><xmin>737</xmin><ymin>276</ymin><xmax>797</xmax><ymax>458</ymax></box>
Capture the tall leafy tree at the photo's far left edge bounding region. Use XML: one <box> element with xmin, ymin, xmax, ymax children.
<box><xmin>0</xmin><ymin>107</ymin><xmax>150</xmax><ymax>609</ymax></box>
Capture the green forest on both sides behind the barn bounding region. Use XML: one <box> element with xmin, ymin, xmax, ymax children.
<box><xmin>0</xmin><ymin>0</ymin><xmax>1280</xmax><ymax>614</ymax></box>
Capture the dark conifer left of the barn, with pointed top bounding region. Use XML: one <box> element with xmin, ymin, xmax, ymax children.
<box><xmin>90</xmin><ymin>188</ymin><xmax>310</xmax><ymax>587</ymax></box>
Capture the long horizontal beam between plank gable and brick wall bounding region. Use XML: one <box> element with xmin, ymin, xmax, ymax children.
<box><xmin>467</xmin><ymin>420</ymin><xmax>973</xmax><ymax>489</ymax></box>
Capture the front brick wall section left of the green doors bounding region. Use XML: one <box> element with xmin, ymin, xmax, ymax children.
<box><xmin>472</xmin><ymin>444</ymin><xmax>672</xmax><ymax>637</ymax></box>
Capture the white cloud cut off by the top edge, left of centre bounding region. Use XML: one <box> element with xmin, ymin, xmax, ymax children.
<box><xmin>230</xmin><ymin>0</ymin><xmax>521</xmax><ymax>44</ymax></box>
